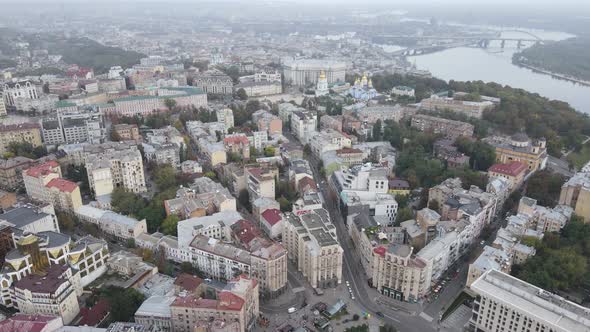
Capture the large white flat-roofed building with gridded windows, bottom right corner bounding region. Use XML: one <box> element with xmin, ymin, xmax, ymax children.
<box><xmin>469</xmin><ymin>270</ymin><xmax>590</xmax><ymax>332</ymax></box>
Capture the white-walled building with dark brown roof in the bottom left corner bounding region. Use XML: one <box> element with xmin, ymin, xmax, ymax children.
<box><xmin>14</xmin><ymin>265</ymin><xmax>80</xmax><ymax>324</ymax></box>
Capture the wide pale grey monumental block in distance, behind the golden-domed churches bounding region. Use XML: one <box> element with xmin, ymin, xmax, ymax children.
<box><xmin>283</xmin><ymin>59</ymin><xmax>346</xmax><ymax>85</ymax></box>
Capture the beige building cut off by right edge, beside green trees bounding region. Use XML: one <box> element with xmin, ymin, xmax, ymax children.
<box><xmin>559</xmin><ymin>172</ymin><xmax>590</xmax><ymax>223</ymax></box>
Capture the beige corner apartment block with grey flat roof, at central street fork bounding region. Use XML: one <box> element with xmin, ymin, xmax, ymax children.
<box><xmin>283</xmin><ymin>209</ymin><xmax>343</xmax><ymax>288</ymax></box>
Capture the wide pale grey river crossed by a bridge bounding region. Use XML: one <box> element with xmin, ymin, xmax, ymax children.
<box><xmin>400</xmin><ymin>31</ymin><xmax>590</xmax><ymax>114</ymax></box>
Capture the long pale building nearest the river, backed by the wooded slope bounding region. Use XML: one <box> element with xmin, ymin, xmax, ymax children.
<box><xmin>420</xmin><ymin>95</ymin><xmax>495</xmax><ymax>119</ymax></box>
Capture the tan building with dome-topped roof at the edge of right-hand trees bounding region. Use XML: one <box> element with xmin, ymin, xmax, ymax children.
<box><xmin>484</xmin><ymin>133</ymin><xmax>548</xmax><ymax>173</ymax></box>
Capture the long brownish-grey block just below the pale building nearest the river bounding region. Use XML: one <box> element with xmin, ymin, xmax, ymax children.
<box><xmin>412</xmin><ymin>114</ymin><xmax>475</xmax><ymax>140</ymax></box>
